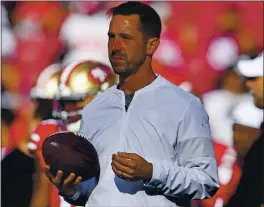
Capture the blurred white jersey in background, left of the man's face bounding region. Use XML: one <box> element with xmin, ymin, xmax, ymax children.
<box><xmin>60</xmin><ymin>13</ymin><xmax>110</xmax><ymax>66</ymax></box>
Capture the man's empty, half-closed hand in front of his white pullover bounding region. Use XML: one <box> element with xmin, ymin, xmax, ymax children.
<box><xmin>111</xmin><ymin>152</ymin><xmax>153</xmax><ymax>181</ymax></box>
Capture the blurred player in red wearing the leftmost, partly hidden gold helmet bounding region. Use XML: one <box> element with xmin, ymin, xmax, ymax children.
<box><xmin>24</xmin><ymin>63</ymin><xmax>66</xmax><ymax>206</ymax></box>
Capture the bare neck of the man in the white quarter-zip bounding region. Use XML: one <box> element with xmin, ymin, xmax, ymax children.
<box><xmin>119</xmin><ymin>66</ymin><xmax>157</xmax><ymax>94</ymax></box>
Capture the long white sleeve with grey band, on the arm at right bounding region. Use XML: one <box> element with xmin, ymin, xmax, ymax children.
<box><xmin>145</xmin><ymin>100</ymin><xmax>219</xmax><ymax>199</ymax></box>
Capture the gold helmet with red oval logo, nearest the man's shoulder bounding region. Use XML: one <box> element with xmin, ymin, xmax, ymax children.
<box><xmin>53</xmin><ymin>60</ymin><xmax>117</xmax><ymax>131</ymax></box>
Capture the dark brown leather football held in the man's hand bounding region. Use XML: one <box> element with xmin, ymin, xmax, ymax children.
<box><xmin>42</xmin><ymin>132</ymin><xmax>100</xmax><ymax>181</ymax></box>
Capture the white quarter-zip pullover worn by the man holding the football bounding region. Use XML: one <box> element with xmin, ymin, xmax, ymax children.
<box><xmin>68</xmin><ymin>76</ymin><xmax>219</xmax><ymax>207</ymax></box>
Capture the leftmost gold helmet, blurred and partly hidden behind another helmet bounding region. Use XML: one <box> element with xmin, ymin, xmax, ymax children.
<box><xmin>30</xmin><ymin>63</ymin><xmax>62</xmax><ymax>99</ymax></box>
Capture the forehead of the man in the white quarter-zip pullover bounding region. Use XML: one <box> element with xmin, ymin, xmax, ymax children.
<box><xmin>109</xmin><ymin>15</ymin><xmax>140</xmax><ymax>32</ymax></box>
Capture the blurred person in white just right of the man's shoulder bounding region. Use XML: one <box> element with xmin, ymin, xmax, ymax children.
<box><xmin>201</xmin><ymin>57</ymin><xmax>250</xmax><ymax>147</ymax></box>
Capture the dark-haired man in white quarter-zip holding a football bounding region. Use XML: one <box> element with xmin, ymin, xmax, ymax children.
<box><xmin>46</xmin><ymin>2</ymin><xmax>219</xmax><ymax>207</ymax></box>
